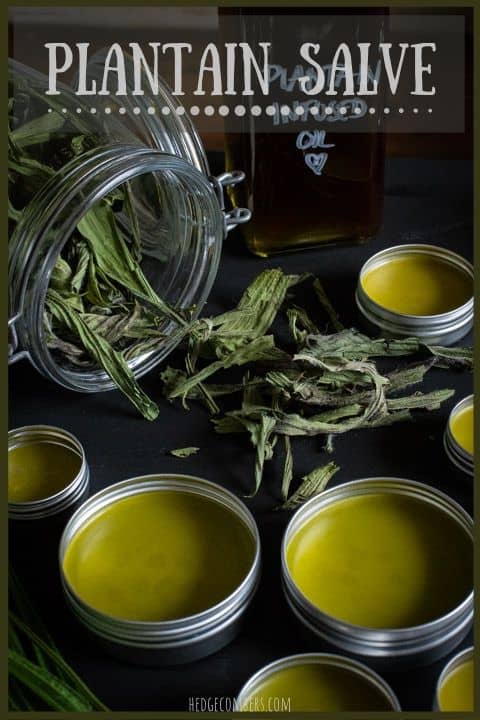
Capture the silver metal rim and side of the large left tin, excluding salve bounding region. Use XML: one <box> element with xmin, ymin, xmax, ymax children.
<box><xmin>59</xmin><ymin>475</ymin><xmax>260</xmax><ymax>665</ymax></box>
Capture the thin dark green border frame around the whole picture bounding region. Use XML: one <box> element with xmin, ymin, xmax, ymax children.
<box><xmin>0</xmin><ymin>0</ymin><xmax>480</xmax><ymax>720</ymax></box>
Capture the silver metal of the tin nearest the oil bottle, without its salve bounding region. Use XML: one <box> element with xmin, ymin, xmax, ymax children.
<box><xmin>355</xmin><ymin>244</ymin><xmax>474</xmax><ymax>345</ymax></box>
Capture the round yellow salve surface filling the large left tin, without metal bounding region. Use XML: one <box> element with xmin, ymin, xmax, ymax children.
<box><xmin>63</xmin><ymin>490</ymin><xmax>254</xmax><ymax>621</ymax></box>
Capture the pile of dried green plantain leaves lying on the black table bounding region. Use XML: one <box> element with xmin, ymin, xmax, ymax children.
<box><xmin>161</xmin><ymin>269</ymin><xmax>473</xmax><ymax>508</ymax></box>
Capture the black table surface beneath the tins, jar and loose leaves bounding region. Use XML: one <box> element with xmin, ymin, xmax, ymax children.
<box><xmin>10</xmin><ymin>158</ymin><xmax>473</xmax><ymax>711</ymax></box>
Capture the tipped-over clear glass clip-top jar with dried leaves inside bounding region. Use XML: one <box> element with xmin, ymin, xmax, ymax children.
<box><xmin>8</xmin><ymin>53</ymin><xmax>250</xmax><ymax>419</ymax></box>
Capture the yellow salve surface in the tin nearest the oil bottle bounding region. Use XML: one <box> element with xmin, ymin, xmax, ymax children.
<box><xmin>362</xmin><ymin>253</ymin><xmax>473</xmax><ymax>316</ymax></box>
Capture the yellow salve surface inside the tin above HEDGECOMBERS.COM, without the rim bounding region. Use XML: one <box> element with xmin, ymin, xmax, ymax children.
<box><xmin>242</xmin><ymin>663</ymin><xmax>391</xmax><ymax>712</ymax></box>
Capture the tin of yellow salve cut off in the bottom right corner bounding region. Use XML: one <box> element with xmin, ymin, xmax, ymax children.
<box><xmin>434</xmin><ymin>647</ymin><xmax>474</xmax><ymax>712</ymax></box>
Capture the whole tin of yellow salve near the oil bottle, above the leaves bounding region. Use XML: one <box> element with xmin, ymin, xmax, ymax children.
<box><xmin>356</xmin><ymin>244</ymin><xmax>473</xmax><ymax>345</ymax></box>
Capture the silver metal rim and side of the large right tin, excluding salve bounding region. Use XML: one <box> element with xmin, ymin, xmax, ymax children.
<box><xmin>282</xmin><ymin>478</ymin><xmax>473</xmax><ymax>669</ymax></box>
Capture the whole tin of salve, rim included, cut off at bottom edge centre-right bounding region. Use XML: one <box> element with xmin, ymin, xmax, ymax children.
<box><xmin>237</xmin><ymin>653</ymin><xmax>400</xmax><ymax>713</ymax></box>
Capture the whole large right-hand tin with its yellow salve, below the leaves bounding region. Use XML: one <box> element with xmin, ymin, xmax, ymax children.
<box><xmin>282</xmin><ymin>478</ymin><xmax>473</xmax><ymax>665</ymax></box>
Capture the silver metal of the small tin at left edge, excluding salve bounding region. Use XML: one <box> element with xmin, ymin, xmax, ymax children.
<box><xmin>8</xmin><ymin>425</ymin><xmax>89</xmax><ymax>521</ymax></box>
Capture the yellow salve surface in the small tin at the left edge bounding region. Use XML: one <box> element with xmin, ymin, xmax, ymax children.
<box><xmin>8</xmin><ymin>442</ymin><xmax>82</xmax><ymax>503</ymax></box>
